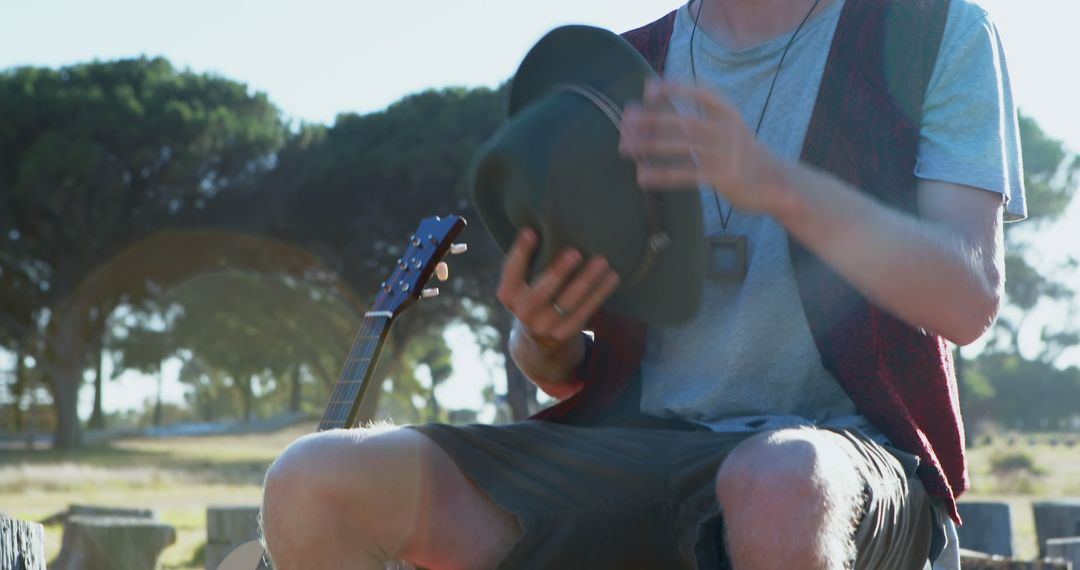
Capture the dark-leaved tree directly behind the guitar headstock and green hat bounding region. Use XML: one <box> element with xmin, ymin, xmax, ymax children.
<box><xmin>244</xmin><ymin>89</ymin><xmax>522</xmax><ymax>419</ymax></box>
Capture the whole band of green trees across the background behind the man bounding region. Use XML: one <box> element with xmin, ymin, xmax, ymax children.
<box><xmin>0</xmin><ymin>58</ymin><xmax>1080</xmax><ymax>447</ymax></box>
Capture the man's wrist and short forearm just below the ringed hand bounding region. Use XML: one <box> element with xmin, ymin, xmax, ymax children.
<box><xmin>510</xmin><ymin>321</ymin><xmax>585</xmax><ymax>399</ymax></box>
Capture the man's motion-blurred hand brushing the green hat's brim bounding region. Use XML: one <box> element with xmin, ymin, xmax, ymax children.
<box><xmin>619</xmin><ymin>81</ymin><xmax>781</xmax><ymax>212</ymax></box>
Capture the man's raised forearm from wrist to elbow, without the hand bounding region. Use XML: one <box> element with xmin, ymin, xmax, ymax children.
<box><xmin>772</xmin><ymin>156</ymin><xmax>1002</xmax><ymax>344</ymax></box>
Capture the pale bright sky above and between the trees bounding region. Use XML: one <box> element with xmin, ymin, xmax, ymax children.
<box><xmin>0</xmin><ymin>0</ymin><xmax>1080</xmax><ymax>418</ymax></box>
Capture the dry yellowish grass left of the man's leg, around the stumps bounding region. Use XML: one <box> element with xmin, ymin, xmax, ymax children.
<box><xmin>0</xmin><ymin>424</ymin><xmax>314</xmax><ymax>570</ymax></box>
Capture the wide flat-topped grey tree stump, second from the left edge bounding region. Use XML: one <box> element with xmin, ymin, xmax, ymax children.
<box><xmin>52</xmin><ymin>516</ymin><xmax>176</xmax><ymax>570</ymax></box>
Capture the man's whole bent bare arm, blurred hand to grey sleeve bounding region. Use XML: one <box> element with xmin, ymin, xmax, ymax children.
<box><xmin>620</xmin><ymin>83</ymin><xmax>1004</xmax><ymax>344</ymax></box>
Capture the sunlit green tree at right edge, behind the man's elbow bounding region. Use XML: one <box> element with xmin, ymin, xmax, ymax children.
<box><xmin>958</xmin><ymin>117</ymin><xmax>1080</xmax><ymax>428</ymax></box>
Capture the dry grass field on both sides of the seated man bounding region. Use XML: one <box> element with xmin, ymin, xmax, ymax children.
<box><xmin>0</xmin><ymin>423</ymin><xmax>1080</xmax><ymax>570</ymax></box>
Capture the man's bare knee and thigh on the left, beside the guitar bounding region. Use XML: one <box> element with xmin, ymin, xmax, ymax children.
<box><xmin>262</xmin><ymin>430</ymin><xmax>521</xmax><ymax>570</ymax></box>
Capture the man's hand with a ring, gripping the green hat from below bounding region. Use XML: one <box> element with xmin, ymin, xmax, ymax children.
<box><xmin>496</xmin><ymin>228</ymin><xmax>619</xmax><ymax>397</ymax></box>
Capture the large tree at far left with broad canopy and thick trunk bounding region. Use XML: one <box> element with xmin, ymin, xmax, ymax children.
<box><xmin>0</xmin><ymin>58</ymin><xmax>285</xmax><ymax>448</ymax></box>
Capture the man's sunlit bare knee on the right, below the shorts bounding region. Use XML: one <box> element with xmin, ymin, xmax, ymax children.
<box><xmin>716</xmin><ymin>430</ymin><xmax>863</xmax><ymax>570</ymax></box>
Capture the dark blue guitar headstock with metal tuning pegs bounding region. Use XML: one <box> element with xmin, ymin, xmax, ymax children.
<box><xmin>372</xmin><ymin>216</ymin><xmax>465</xmax><ymax>318</ymax></box>
